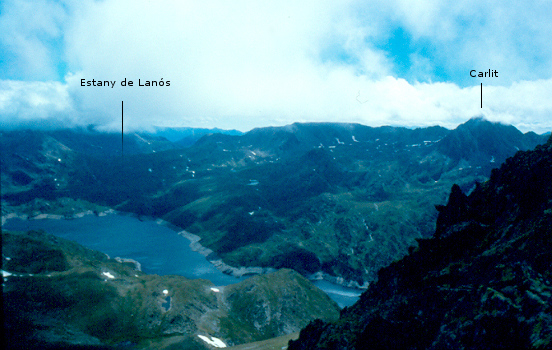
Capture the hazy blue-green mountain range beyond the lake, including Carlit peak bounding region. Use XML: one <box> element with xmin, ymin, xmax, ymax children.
<box><xmin>0</xmin><ymin>119</ymin><xmax>546</xmax><ymax>286</ymax></box>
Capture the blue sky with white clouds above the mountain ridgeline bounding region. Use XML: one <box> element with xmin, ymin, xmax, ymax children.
<box><xmin>0</xmin><ymin>0</ymin><xmax>552</xmax><ymax>133</ymax></box>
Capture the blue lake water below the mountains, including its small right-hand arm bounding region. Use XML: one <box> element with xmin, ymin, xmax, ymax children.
<box><xmin>2</xmin><ymin>214</ymin><xmax>360</xmax><ymax>307</ymax></box>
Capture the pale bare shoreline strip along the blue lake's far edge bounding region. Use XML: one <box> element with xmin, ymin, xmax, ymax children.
<box><xmin>2</xmin><ymin>209</ymin><xmax>369</xmax><ymax>290</ymax></box>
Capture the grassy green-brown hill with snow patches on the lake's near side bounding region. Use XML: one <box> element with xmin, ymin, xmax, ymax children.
<box><xmin>2</xmin><ymin>231</ymin><xmax>339</xmax><ymax>349</ymax></box>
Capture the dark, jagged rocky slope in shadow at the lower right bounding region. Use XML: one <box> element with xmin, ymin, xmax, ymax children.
<box><xmin>289</xmin><ymin>139</ymin><xmax>552</xmax><ymax>350</ymax></box>
